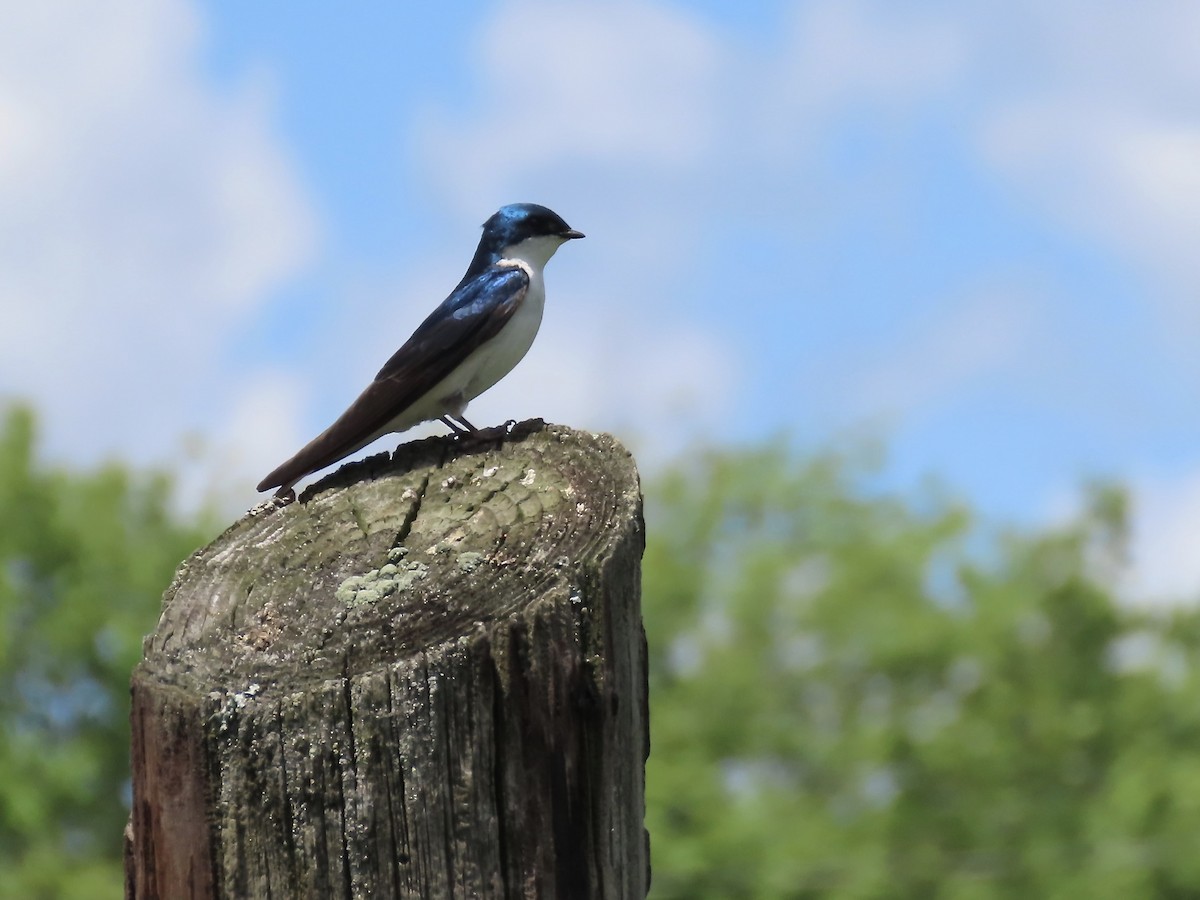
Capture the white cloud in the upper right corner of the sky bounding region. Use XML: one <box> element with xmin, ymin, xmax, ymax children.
<box><xmin>964</xmin><ymin>0</ymin><xmax>1200</xmax><ymax>329</ymax></box>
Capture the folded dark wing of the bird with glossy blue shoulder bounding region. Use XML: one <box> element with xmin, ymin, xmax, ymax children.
<box><xmin>258</xmin><ymin>266</ymin><xmax>529</xmax><ymax>491</ymax></box>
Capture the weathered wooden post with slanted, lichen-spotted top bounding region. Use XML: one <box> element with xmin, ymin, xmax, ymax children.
<box><xmin>126</xmin><ymin>421</ymin><xmax>649</xmax><ymax>900</ymax></box>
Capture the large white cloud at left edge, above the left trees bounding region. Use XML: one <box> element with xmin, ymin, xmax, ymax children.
<box><xmin>0</xmin><ymin>0</ymin><xmax>314</xmax><ymax>472</ymax></box>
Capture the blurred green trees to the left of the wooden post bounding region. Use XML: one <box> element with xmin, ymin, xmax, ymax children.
<box><xmin>0</xmin><ymin>408</ymin><xmax>214</xmax><ymax>900</ymax></box>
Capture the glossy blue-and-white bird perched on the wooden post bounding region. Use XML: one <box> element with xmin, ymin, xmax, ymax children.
<box><xmin>258</xmin><ymin>203</ymin><xmax>583</xmax><ymax>503</ymax></box>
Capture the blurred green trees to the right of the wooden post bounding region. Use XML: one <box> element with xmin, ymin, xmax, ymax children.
<box><xmin>644</xmin><ymin>446</ymin><xmax>1200</xmax><ymax>900</ymax></box>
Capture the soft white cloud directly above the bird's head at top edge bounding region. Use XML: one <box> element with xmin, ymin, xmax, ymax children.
<box><xmin>422</xmin><ymin>0</ymin><xmax>721</xmax><ymax>210</ymax></box>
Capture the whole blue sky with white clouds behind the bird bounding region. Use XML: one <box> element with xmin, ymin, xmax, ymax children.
<box><xmin>0</xmin><ymin>0</ymin><xmax>1200</xmax><ymax>595</ymax></box>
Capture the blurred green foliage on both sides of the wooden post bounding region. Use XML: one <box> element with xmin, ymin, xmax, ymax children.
<box><xmin>0</xmin><ymin>409</ymin><xmax>1200</xmax><ymax>900</ymax></box>
